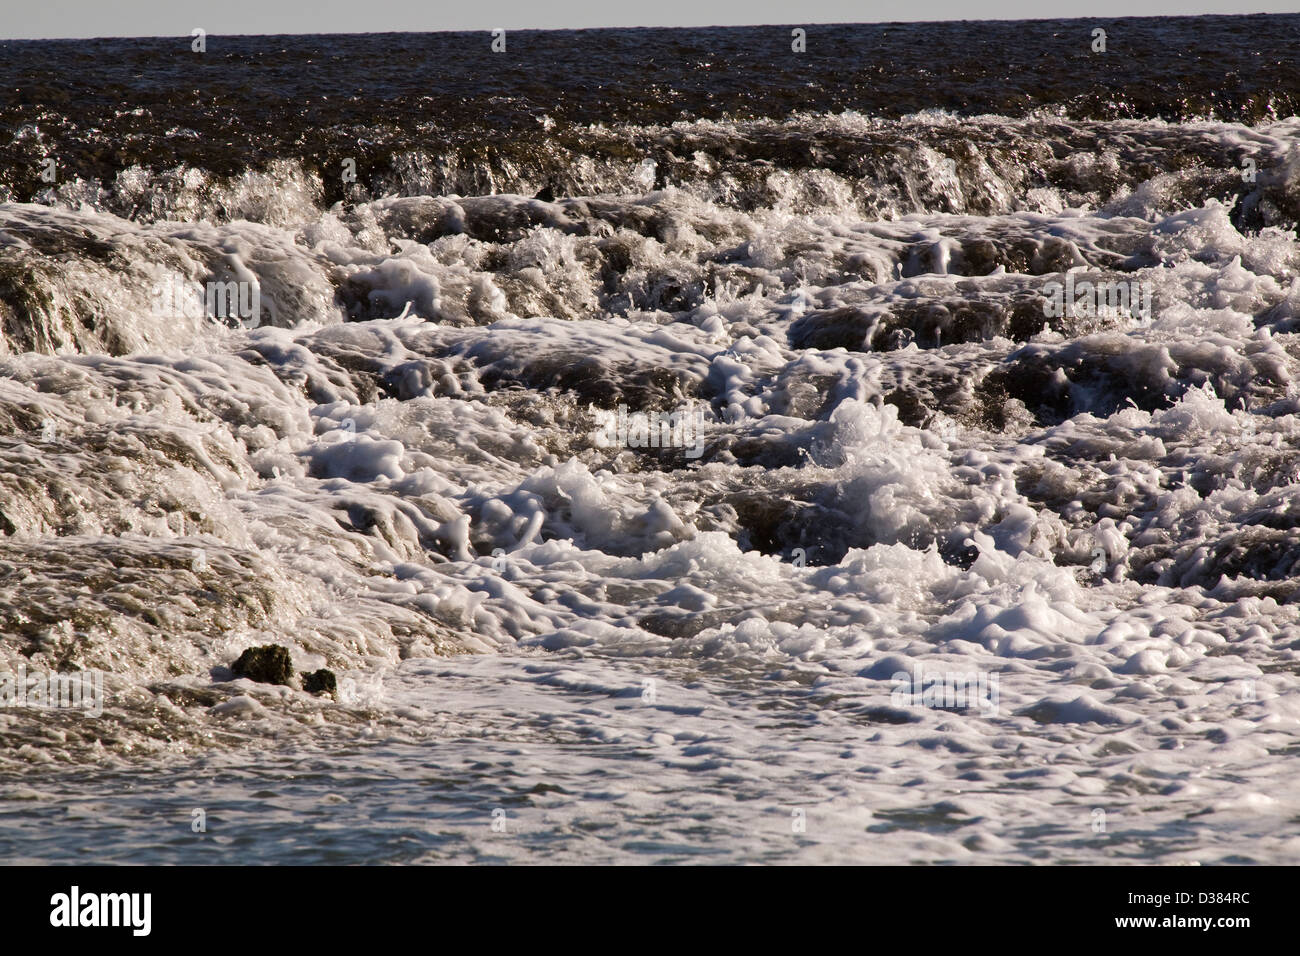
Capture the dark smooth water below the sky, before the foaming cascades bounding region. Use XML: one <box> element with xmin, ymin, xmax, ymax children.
<box><xmin>0</xmin><ymin>16</ymin><xmax>1300</xmax><ymax>202</ymax></box>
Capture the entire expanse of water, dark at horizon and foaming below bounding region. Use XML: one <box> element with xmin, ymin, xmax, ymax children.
<box><xmin>0</xmin><ymin>16</ymin><xmax>1300</xmax><ymax>864</ymax></box>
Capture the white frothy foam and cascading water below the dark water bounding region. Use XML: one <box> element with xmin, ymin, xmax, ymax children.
<box><xmin>0</xmin><ymin>108</ymin><xmax>1300</xmax><ymax>862</ymax></box>
